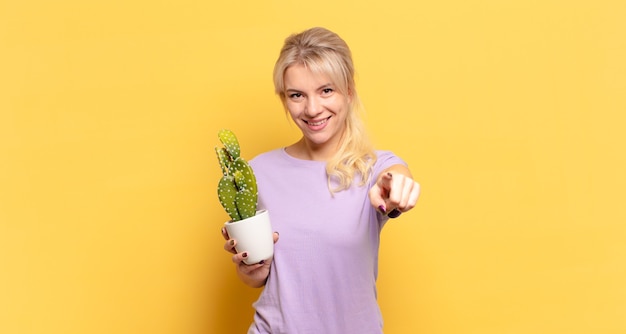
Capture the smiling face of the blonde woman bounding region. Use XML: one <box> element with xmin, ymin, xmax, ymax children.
<box><xmin>284</xmin><ymin>64</ymin><xmax>350</xmax><ymax>150</ymax></box>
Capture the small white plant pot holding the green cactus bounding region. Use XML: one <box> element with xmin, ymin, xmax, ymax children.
<box><xmin>224</xmin><ymin>210</ymin><xmax>274</xmax><ymax>264</ymax></box>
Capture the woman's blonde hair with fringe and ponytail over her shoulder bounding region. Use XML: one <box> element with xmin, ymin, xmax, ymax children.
<box><xmin>274</xmin><ymin>27</ymin><xmax>376</xmax><ymax>193</ymax></box>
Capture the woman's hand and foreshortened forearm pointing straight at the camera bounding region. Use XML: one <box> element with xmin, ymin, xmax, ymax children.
<box><xmin>369</xmin><ymin>164</ymin><xmax>420</xmax><ymax>217</ymax></box>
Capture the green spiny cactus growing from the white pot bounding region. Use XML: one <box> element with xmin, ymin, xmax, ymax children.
<box><xmin>215</xmin><ymin>129</ymin><xmax>258</xmax><ymax>222</ymax></box>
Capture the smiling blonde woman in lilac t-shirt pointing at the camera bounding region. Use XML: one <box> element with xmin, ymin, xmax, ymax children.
<box><xmin>222</xmin><ymin>28</ymin><xmax>419</xmax><ymax>334</ymax></box>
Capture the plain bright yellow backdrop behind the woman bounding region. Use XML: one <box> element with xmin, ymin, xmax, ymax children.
<box><xmin>0</xmin><ymin>0</ymin><xmax>626</xmax><ymax>334</ymax></box>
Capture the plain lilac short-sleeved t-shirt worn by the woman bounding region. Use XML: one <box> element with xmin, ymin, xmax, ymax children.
<box><xmin>248</xmin><ymin>149</ymin><xmax>405</xmax><ymax>334</ymax></box>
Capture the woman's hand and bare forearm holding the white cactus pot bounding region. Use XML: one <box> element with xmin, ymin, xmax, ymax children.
<box><xmin>222</xmin><ymin>228</ymin><xmax>278</xmax><ymax>288</ymax></box>
